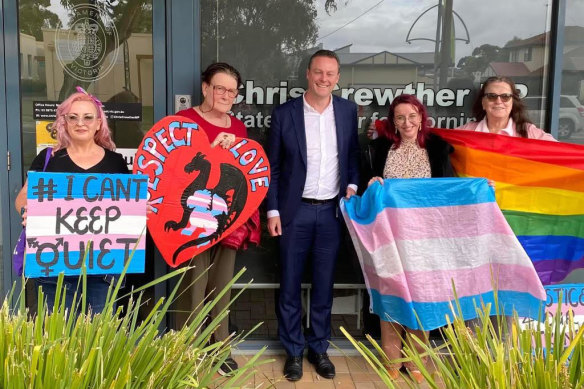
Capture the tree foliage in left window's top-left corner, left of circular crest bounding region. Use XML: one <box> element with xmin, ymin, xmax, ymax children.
<box><xmin>18</xmin><ymin>0</ymin><xmax>61</xmax><ymax>41</ymax></box>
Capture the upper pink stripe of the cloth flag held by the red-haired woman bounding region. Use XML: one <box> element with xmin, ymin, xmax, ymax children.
<box><xmin>351</xmin><ymin>203</ymin><xmax>513</xmax><ymax>252</ymax></box>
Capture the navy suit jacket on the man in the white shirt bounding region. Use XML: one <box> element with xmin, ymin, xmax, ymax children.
<box><xmin>267</xmin><ymin>95</ymin><xmax>360</xmax><ymax>226</ymax></box>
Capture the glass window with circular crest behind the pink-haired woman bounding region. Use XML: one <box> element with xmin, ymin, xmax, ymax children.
<box><xmin>18</xmin><ymin>0</ymin><xmax>153</xmax><ymax>171</ymax></box>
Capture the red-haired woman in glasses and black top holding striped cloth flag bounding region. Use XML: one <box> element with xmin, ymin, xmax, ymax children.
<box><xmin>368</xmin><ymin>95</ymin><xmax>454</xmax><ymax>383</ymax></box>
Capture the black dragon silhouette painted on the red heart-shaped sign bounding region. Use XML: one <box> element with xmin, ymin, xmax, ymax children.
<box><xmin>164</xmin><ymin>152</ymin><xmax>247</xmax><ymax>264</ymax></box>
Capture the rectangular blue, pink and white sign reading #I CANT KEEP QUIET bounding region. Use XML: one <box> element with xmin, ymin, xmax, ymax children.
<box><xmin>24</xmin><ymin>172</ymin><xmax>148</xmax><ymax>277</ymax></box>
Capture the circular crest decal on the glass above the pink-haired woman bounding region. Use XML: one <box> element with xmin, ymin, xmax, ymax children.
<box><xmin>55</xmin><ymin>4</ymin><xmax>119</xmax><ymax>81</ymax></box>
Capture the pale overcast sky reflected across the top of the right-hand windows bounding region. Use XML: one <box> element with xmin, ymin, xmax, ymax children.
<box><xmin>317</xmin><ymin>0</ymin><xmax>584</xmax><ymax>61</ymax></box>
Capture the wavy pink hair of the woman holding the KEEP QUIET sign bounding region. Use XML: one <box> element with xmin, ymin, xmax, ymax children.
<box><xmin>53</xmin><ymin>92</ymin><xmax>116</xmax><ymax>151</ymax></box>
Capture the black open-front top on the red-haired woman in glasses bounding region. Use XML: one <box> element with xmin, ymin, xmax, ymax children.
<box><xmin>369</xmin><ymin>134</ymin><xmax>456</xmax><ymax>178</ymax></box>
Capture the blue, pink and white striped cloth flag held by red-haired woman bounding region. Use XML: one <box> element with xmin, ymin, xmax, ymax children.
<box><xmin>341</xmin><ymin>178</ymin><xmax>546</xmax><ymax>330</ymax></box>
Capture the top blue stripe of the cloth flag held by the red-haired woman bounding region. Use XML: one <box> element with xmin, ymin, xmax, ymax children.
<box><xmin>345</xmin><ymin>178</ymin><xmax>495</xmax><ymax>224</ymax></box>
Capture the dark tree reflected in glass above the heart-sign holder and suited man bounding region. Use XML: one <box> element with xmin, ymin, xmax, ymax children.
<box><xmin>201</xmin><ymin>0</ymin><xmax>318</xmax><ymax>82</ymax></box>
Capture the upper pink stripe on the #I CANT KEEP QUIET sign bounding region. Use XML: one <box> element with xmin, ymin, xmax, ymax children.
<box><xmin>27</xmin><ymin>199</ymin><xmax>146</xmax><ymax>216</ymax></box>
